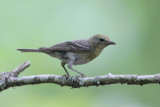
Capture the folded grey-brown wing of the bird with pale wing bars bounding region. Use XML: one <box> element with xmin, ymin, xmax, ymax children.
<box><xmin>40</xmin><ymin>40</ymin><xmax>91</xmax><ymax>52</ymax></box>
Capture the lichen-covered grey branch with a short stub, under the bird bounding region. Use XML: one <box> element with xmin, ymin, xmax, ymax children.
<box><xmin>0</xmin><ymin>61</ymin><xmax>160</xmax><ymax>92</ymax></box>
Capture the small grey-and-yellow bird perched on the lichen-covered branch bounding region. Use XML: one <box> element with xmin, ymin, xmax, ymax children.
<box><xmin>17</xmin><ymin>34</ymin><xmax>116</xmax><ymax>77</ymax></box>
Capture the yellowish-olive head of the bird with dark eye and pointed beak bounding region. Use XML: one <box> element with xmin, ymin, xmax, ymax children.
<box><xmin>89</xmin><ymin>34</ymin><xmax>116</xmax><ymax>49</ymax></box>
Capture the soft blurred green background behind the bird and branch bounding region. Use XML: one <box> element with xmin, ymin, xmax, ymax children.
<box><xmin>0</xmin><ymin>0</ymin><xmax>160</xmax><ymax>107</ymax></box>
